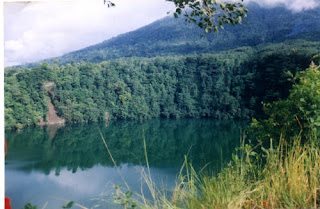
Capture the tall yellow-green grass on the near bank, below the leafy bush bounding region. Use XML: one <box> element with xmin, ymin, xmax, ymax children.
<box><xmin>122</xmin><ymin>133</ymin><xmax>320</xmax><ymax>208</ymax></box>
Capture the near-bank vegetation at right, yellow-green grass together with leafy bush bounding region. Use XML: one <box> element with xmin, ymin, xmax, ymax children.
<box><xmin>116</xmin><ymin>63</ymin><xmax>320</xmax><ymax>209</ymax></box>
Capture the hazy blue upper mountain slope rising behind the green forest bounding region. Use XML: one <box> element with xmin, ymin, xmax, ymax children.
<box><xmin>38</xmin><ymin>3</ymin><xmax>320</xmax><ymax>64</ymax></box>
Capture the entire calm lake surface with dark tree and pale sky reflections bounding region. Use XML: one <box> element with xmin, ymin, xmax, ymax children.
<box><xmin>5</xmin><ymin>119</ymin><xmax>247</xmax><ymax>209</ymax></box>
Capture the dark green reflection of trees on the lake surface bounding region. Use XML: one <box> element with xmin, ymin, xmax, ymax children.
<box><xmin>6</xmin><ymin>119</ymin><xmax>247</xmax><ymax>175</ymax></box>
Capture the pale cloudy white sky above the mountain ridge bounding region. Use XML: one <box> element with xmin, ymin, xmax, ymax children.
<box><xmin>4</xmin><ymin>0</ymin><xmax>320</xmax><ymax>66</ymax></box>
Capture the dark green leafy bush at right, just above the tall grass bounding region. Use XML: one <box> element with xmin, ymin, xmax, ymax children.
<box><xmin>251</xmin><ymin>63</ymin><xmax>320</xmax><ymax>140</ymax></box>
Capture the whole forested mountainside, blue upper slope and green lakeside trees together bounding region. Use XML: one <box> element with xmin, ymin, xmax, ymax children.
<box><xmin>5</xmin><ymin>4</ymin><xmax>320</xmax><ymax>129</ymax></box>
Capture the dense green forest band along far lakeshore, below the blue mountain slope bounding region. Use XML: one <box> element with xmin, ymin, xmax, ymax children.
<box><xmin>5</xmin><ymin>40</ymin><xmax>320</xmax><ymax>129</ymax></box>
